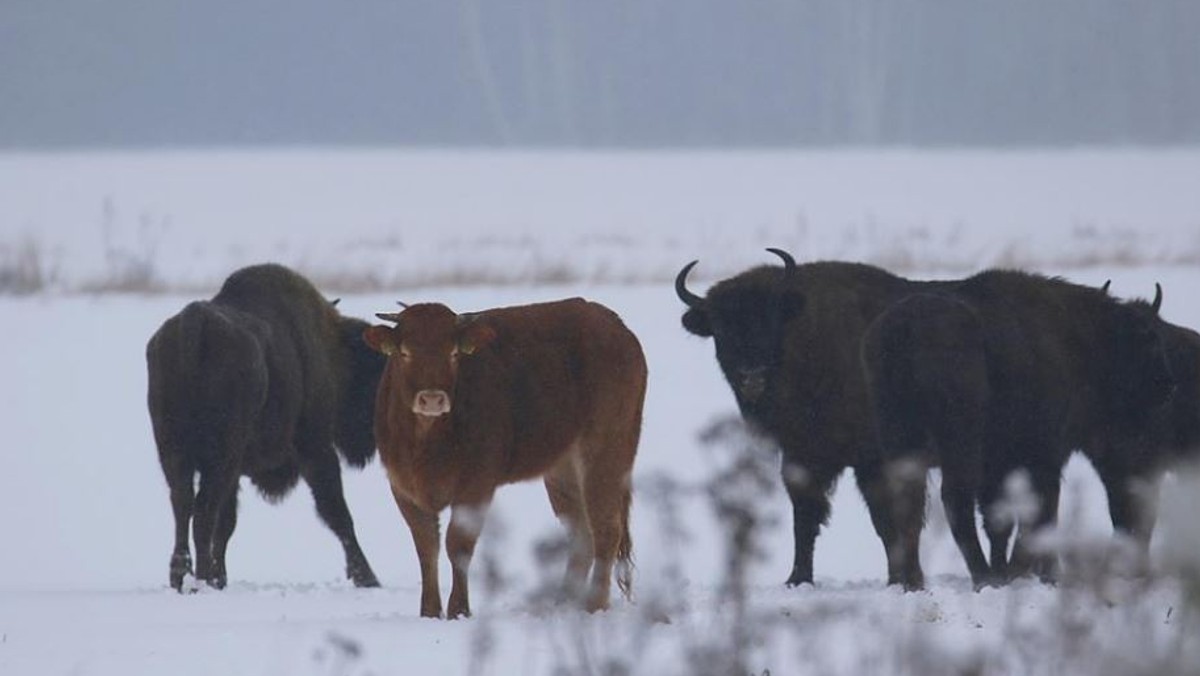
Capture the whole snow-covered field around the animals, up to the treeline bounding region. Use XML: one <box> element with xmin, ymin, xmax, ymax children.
<box><xmin>0</xmin><ymin>151</ymin><xmax>1200</xmax><ymax>676</ymax></box>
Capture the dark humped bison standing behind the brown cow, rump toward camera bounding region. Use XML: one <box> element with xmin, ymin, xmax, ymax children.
<box><xmin>146</xmin><ymin>264</ymin><xmax>384</xmax><ymax>590</ymax></box>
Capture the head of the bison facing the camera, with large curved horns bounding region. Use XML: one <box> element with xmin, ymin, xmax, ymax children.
<box><xmin>676</xmin><ymin>249</ymin><xmax>804</xmax><ymax>413</ymax></box>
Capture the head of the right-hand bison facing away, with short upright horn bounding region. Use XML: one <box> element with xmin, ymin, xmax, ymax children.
<box><xmin>1111</xmin><ymin>283</ymin><xmax>1176</xmax><ymax>415</ymax></box>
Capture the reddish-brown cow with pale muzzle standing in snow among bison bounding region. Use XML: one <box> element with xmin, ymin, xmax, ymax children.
<box><xmin>364</xmin><ymin>298</ymin><xmax>646</xmax><ymax>618</ymax></box>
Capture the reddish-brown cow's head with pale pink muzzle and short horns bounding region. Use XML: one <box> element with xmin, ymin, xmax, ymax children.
<box><xmin>362</xmin><ymin>304</ymin><xmax>496</xmax><ymax>419</ymax></box>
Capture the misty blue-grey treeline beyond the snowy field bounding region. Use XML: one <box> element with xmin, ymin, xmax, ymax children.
<box><xmin>0</xmin><ymin>0</ymin><xmax>1200</xmax><ymax>148</ymax></box>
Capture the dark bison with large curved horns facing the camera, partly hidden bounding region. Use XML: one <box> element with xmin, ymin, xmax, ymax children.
<box><xmin>676</xmin><ymin>250</ymin><xmax>922</xmax><ymax>586</ymax></box>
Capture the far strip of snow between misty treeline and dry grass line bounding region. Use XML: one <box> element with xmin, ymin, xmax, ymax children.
<box><xmin>7</xmin><ymin>149</ymin><xmax>1200</xmax><ymax>292</ymax></box>
